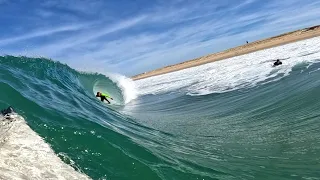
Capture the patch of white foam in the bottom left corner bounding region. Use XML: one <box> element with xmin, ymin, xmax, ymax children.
<box><xmin>0</xmin><ymin>114</ymin><xmax>90</xmax><ymax>180</ymax></box>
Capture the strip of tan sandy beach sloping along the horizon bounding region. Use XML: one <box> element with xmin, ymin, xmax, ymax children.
<box><xmin>131</xmin><ymin>26</ymin><xmax>320</xmax><ymax>80</ymax></box>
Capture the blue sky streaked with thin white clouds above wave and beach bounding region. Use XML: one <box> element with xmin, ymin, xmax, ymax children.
<box><xmin>0</xmin><ymin>0</ymin><xmax>320</xmax><ymax>76</ymax></box>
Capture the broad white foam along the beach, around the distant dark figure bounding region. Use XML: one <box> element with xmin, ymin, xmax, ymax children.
<box><xmin>136</xmin><ymin>37</ymin><xmax>320</xmax><ymax>95</ymax></box>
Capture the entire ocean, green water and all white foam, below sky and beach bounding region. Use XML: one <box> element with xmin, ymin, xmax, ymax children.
<box><xmin>0</xmin><ymin>37</ymin><xmax>320</xmax><ymax>180</ymax></box>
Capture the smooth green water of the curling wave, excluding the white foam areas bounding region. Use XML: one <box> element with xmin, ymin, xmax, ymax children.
<box><xmin>0</xmin><ymin>56</ymin><xmax>320</xmax><ymax>180</ymax></box>
